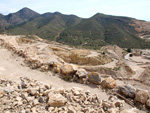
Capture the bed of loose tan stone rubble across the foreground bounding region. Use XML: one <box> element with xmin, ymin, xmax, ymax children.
<box><xmin>0</xmin><ymin>78</ymin><xmax>124</xmax><ymax>113</ymax></box>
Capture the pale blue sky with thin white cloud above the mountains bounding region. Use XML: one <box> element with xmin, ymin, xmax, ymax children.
<box><xmin>0</xmin><ymin>0</ymin><xmax>150</xmax><ymax>21</ymax></box>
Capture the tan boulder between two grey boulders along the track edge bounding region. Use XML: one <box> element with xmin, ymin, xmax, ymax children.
<box><xmin>101</xmin><ymin>77</ymin><xmax>116</xmax><ymax>89</ymax></box>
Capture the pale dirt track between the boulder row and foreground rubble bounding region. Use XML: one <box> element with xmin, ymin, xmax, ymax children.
<box><xmin>0</xmin><ymin>48</ymin><xmax>111</xmax><ymax>99</ymax></box>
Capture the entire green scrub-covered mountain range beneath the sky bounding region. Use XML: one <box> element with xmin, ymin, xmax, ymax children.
<box><xmin>0</xmin><ymin>8</ymin><xmax>150</xmax><ymax>49</ymax></box>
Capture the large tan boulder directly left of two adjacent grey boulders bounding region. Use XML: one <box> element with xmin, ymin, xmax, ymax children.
<box><xmin>61</xmin><ymin>64</ymin><xmax>78</xmax><ymax>75</ymax></box>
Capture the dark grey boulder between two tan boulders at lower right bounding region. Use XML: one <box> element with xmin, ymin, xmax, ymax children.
<box><xmin>119</xmin><ymin>85</ymin><xmax>136</xmax><ymax>98</ymax></box>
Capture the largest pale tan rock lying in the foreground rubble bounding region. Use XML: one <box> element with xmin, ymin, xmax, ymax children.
<box><xmin>48</xmin><ymin>93</ymin><xmax>67</xmax><ymax>107</ymax></box>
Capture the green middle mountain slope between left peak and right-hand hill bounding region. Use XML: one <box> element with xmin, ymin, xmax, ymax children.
<box><xmin>8</xmin><ymin>12</ymin><xmax>82</xmax><ymax>40</ymax></box>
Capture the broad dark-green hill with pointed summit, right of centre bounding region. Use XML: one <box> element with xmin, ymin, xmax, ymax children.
<box><xmin>57</xmin><ymin>13</ymin><xmax>148</xmax><ymax>48</ymax></box>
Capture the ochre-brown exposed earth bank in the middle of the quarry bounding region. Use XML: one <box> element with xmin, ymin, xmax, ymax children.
<box><xmin>56</xmin><ymin>49</ymin><xmax>112</xmax><ymax>65</ymax></box>
